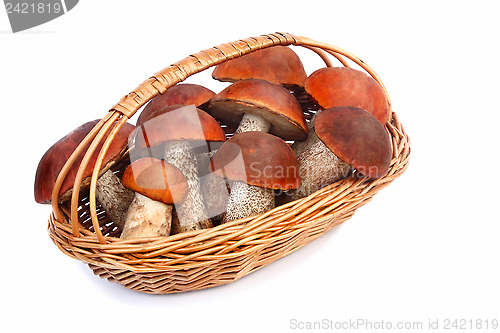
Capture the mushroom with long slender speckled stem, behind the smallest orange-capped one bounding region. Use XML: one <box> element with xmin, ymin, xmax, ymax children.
<box><xmin>134</xmin><ymin>106</ymin><xmax>226</xmax><ymax>233</ymax></box>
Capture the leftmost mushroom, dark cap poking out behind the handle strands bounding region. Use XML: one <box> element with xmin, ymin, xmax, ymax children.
<box><xmin>35</xmin><ymin>120</ymin><xmax>135</xmax><ymax>229</ymax></box>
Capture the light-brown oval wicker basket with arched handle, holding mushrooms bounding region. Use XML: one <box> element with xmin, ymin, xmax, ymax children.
<box><xmin>48</xmin><ymin>33</ymin><xmax>410</xmax><ymax>294</ymax></box>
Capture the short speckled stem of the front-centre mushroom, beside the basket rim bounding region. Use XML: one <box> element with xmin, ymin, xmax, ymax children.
<box><xmin>222</xmin><ymin>182</ymin><xmax>275</xmax><ymax>223</ymax></box>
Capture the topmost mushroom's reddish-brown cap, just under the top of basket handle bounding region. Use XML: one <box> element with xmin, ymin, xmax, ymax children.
<box><xmin>212</xmin><ymin>46</ymin><xmax>307</xmax><ymax>87</ymax></box>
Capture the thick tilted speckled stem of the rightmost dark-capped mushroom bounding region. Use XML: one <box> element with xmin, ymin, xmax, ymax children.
<box><xmin>287</xmin><ymin>129</ymin><xmax>353</xmax><ymax>201</ymax></box>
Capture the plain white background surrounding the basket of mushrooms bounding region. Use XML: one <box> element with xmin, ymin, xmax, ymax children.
<box><xmin>0</xmin><ymin>0</ymin><xmax>500</xmax><ymax>332</ymax></box>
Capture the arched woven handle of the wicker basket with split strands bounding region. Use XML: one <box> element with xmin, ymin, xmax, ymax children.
<box><xmin>52</xmin><ymin>33</ymin><xmax>391</xmax><ymax>244</ymax></box>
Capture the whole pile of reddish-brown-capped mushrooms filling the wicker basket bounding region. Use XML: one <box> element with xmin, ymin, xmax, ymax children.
<box><xmin>35</xmin><ymin>46</ymin><xmax>392</xmax><ymax>239</ymax></box>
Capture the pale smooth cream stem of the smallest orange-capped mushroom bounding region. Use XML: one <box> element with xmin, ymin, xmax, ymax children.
<box><xmin>120</xmin><ymin>193</ymin><xmax>172</xmax><ymax>239</ymax></box>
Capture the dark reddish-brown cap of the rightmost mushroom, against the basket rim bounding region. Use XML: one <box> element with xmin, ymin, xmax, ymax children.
<box><xmin>314</xmin><ymin>106</ymin><xmax>392</xmax><ymax>178</ymax></box>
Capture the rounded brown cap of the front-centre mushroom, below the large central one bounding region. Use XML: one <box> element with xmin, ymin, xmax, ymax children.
<box><xmin>213</xmin><ymin>132</ymin><xmax>300</xmax><ymax>190</ymax></box>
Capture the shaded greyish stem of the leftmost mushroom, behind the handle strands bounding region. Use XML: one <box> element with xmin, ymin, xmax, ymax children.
<box><xmin>96</xmin><ymin>170</ymin><xmax>135</xmax><ymax>230</ymax></box>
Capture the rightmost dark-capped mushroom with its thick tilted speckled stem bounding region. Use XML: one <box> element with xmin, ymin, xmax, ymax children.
<box><xmin>287</xmin><ymin>106</ymin><xmax>392</xmax><ymax>200</ymax></box>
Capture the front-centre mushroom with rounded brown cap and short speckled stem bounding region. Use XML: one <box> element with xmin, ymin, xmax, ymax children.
<box><xmin>213</xmin><ymin>132</ymin><xmax>300</xmax><ymax>223</ymax></box>
